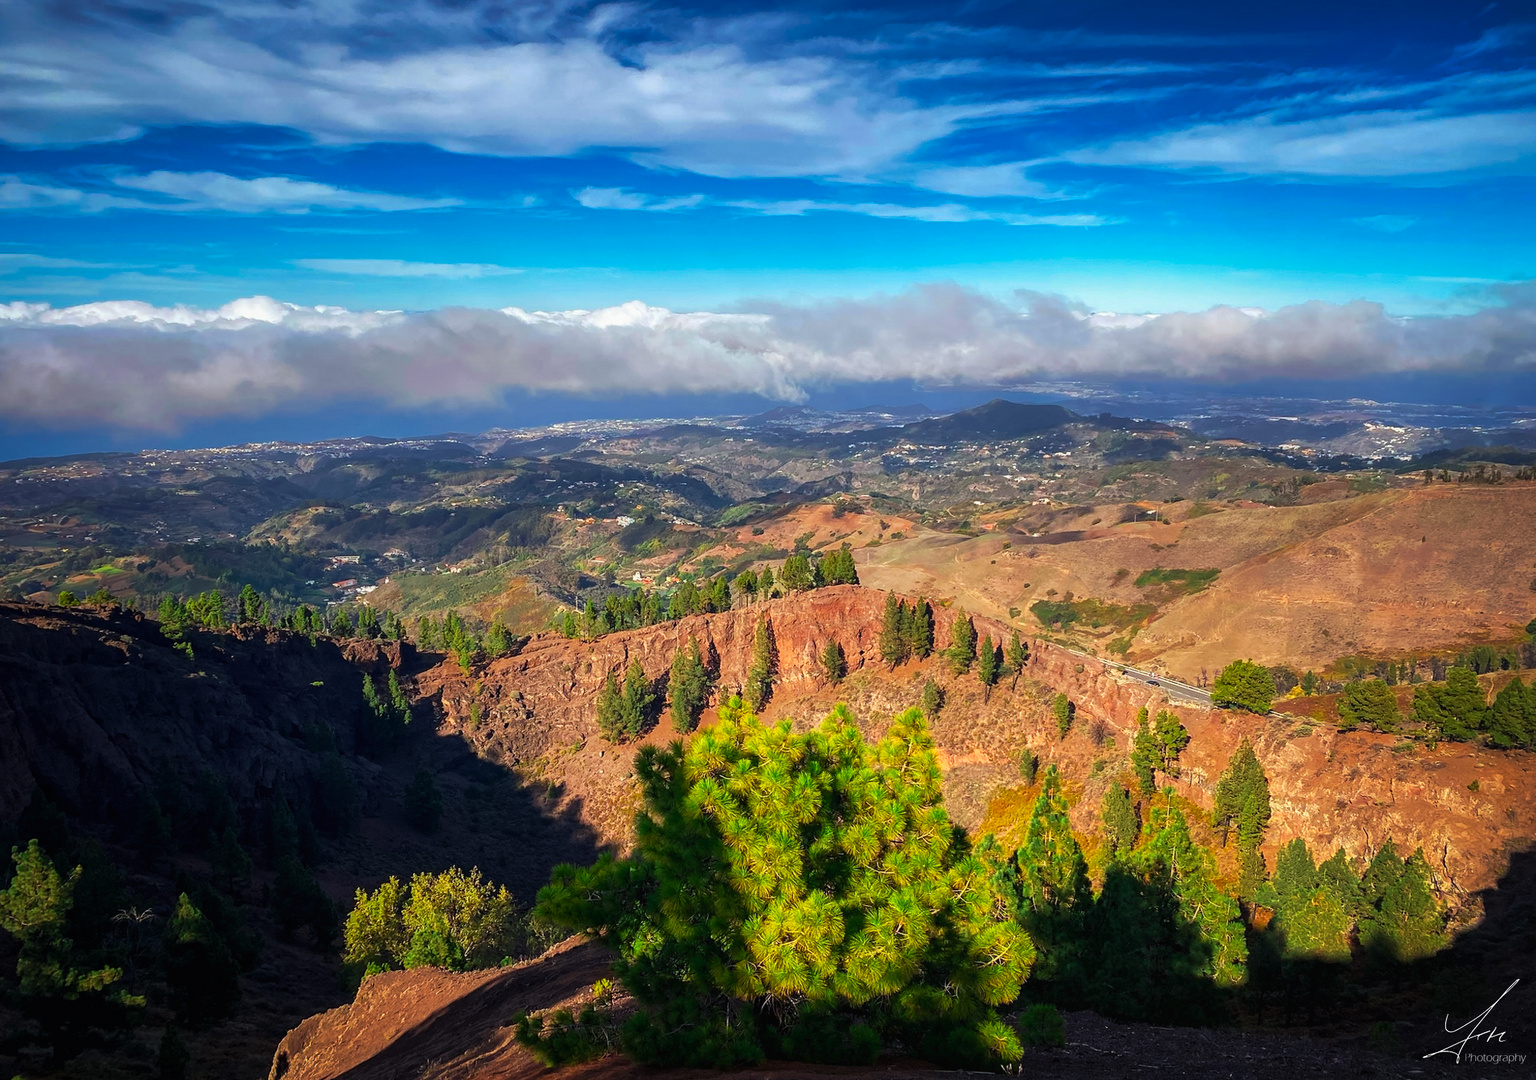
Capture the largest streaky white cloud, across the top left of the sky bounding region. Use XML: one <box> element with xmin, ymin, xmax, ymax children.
<box><xmin>0</xmin><ymin>2</ymin><xmax>969</xmax><ymax>177</ymax></box>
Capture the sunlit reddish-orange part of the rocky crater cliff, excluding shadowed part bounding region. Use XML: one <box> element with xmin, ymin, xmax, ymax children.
<box><xmin>418</xmin><ymin>587</ymin><xmax>1536</xmax><ymax>903</ymax></box>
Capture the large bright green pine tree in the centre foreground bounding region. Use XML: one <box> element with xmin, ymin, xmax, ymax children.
<box><xmin>538</xmin><ymin>701</ymin><xmax>1034</xmax><ymax>1068</ymax></box>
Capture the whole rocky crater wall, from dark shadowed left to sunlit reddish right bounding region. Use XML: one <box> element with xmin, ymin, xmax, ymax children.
<box><xmin>0</xmin><ymin>587</ymin><xmax>1536</xmax><ymax>921</ymax></box>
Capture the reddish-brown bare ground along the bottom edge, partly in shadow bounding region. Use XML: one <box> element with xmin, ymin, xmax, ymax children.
<box><xmin>269</xmin><ymin>939</ymin><xmax>1511</xmax><ymax>1080</ymax></box>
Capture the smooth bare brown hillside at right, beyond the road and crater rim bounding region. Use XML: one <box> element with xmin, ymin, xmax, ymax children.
<box><xmin>859</xmin><ymin>484</ymin><xmax>1536</xmax><ymax>679</ymax></box>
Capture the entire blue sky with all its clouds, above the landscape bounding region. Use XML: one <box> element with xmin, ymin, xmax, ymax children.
<box><xmin>0</xmin><ymin>0</ymin><xmax>1536</xmax><ymax>441</ymax></box>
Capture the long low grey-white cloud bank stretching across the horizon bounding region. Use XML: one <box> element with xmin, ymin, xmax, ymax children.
<box><xmin>0</xmin><ymin>283</ymin><xmax>1536</xmax><ymax>430</ymax></box>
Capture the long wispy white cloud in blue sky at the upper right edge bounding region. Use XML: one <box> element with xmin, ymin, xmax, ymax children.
<box><xmin>1061</xmin><ymin>111</ymin><xmax>1536</xmax><ymax>177</ymax></box>
